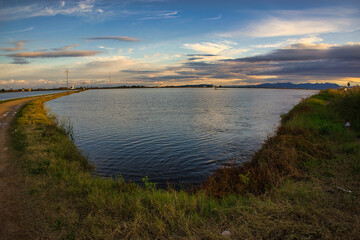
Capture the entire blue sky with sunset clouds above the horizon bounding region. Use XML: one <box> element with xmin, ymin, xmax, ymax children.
<box><xmin>0</xmin><ymin>0</ymin><xmax>360</xmax><ymax>89</ymax></box>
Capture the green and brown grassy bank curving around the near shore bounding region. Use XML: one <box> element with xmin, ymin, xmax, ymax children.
<box><xmin>11</xmin><ymin>89</ymin><xmax>360</xmax><ymax>239</ymax></box>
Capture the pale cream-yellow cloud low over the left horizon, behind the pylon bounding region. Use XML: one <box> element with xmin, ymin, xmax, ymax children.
<box><xmin>0</xmin><ymin>56</ymin><xmax>148</xmax><ymax>87</ymax></box>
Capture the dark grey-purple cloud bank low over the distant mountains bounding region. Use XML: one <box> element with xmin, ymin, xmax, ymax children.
<box><xmin>139</xmin><ymin>43</ymin><xmax>360</xmax><ymax>85</ymax></box>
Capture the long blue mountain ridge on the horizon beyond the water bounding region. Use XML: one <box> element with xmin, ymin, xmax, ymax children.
<box><xmin>227</xmin><ymin>82</ymin><xmax>340</xmax><ymax>90</ymax></box>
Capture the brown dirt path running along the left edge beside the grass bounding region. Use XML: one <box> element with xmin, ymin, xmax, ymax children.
<box><xmin>0</xmin><ymin>97</ymin><xmax>36</xmax><ymax>240</ymax></box>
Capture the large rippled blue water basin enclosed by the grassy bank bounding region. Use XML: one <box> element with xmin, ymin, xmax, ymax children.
<box><xmin>47</xmin><ymin>88</ymin><xmax>317</xmax><ymax>186</ymax></box>
